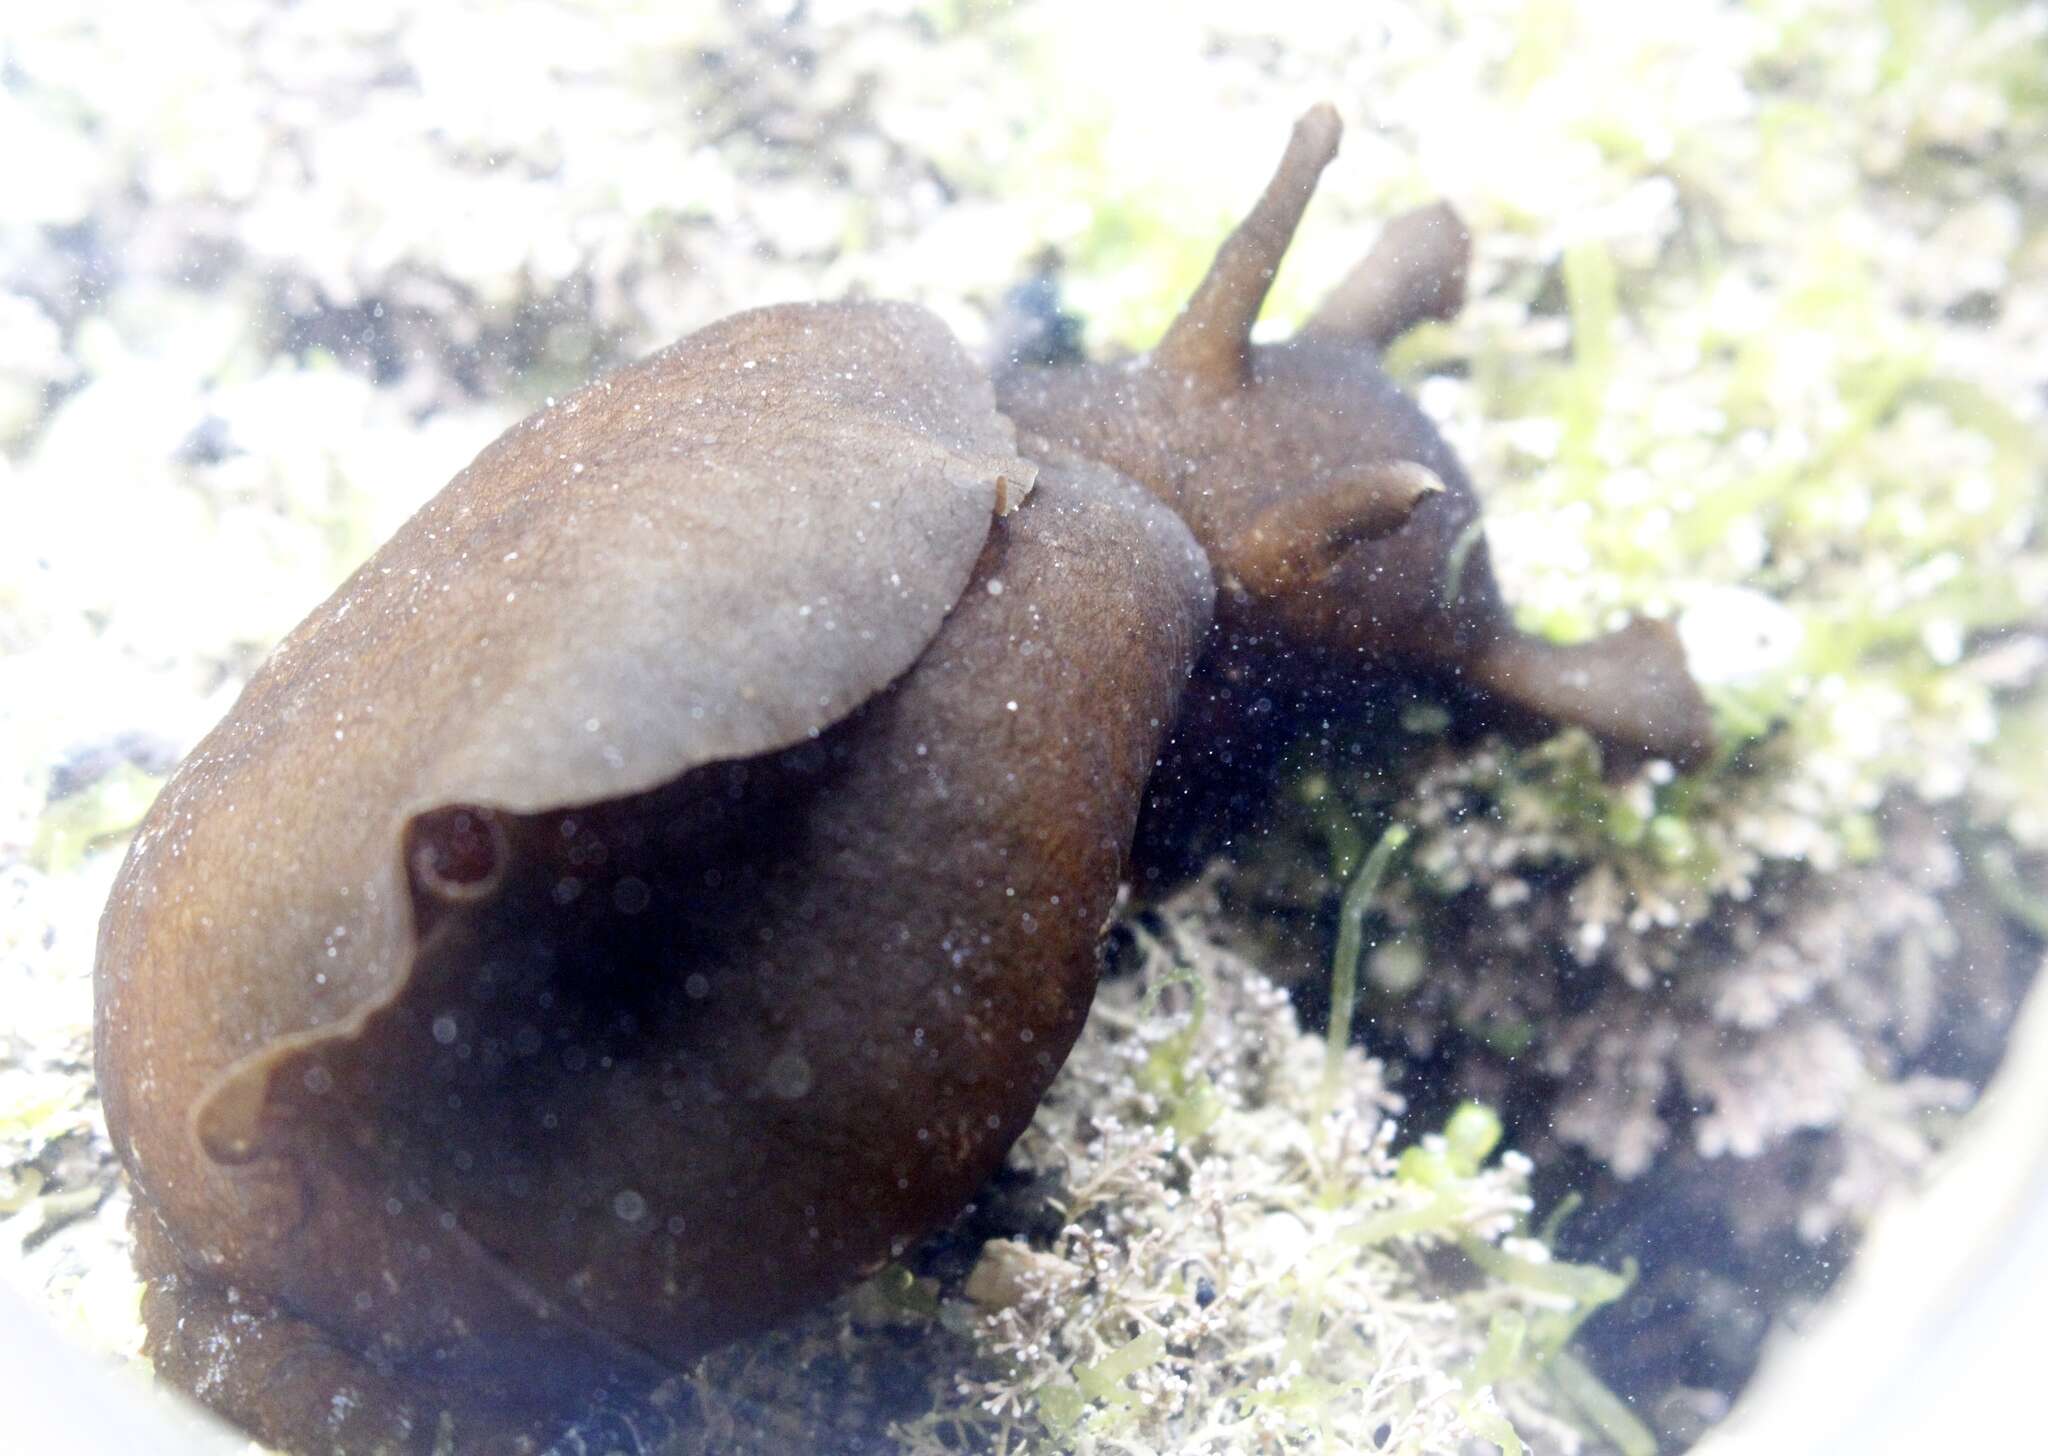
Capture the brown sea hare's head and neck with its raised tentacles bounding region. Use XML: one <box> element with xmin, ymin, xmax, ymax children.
<box><xmin>995</xmin><ymin>106</ymin><xmax>1712</xmax><ymax>768</ymax></box>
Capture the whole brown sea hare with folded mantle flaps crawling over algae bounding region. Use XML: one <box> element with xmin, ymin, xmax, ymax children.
<box><xmin>96</xmin><ymin>106</ymin><xmax>1708</xmax><ymax>1454</ymax></box>
